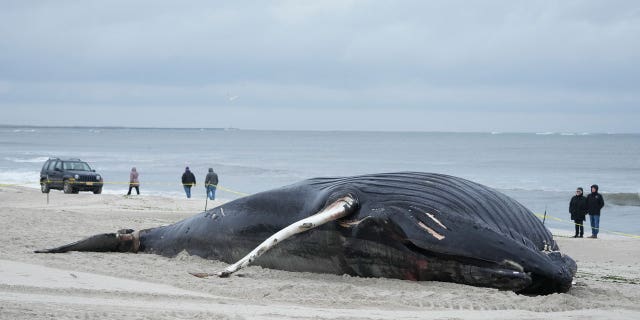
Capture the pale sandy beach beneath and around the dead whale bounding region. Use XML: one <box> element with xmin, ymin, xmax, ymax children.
<box><xmin>0</xmin><ymin>186</ymin><xmax>640</xmax><ymax>319</ymax></box>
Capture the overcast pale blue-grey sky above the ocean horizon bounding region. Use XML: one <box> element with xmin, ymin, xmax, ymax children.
<box><xmin>0</xmin><ymin>0</ymin><xmax>640</xmax><ymax>132</ymax></box>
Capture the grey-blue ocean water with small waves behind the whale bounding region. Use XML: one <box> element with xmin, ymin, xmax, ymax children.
<box><xmin>0</xmin><ymin>126</ymin><xmax>640</xmax><ymax>235</ymax></box>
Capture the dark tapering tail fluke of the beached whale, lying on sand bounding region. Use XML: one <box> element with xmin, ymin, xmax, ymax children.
<box><xmin>34</xmin><ymin>229</ymin><xmax>140</xmax><ymax>253</ymax></box>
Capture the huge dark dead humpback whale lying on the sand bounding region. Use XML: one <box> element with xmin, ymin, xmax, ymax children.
<box><xmin>36</xmin><ymin>172</ymin><xmax>577</xmax><ymax>294</ymax></box>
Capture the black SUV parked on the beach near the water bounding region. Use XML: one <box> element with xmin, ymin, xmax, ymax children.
<box><xmin>40</xmin><ymin>158</ymin><xmax>104</xmax><ymax>194</ymax></box>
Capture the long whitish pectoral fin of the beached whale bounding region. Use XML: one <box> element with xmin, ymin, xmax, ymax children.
<box><xmin>190</xmin><ymin>196</ymin><xmax>356</xmax><ymax>278</ymax></box>
